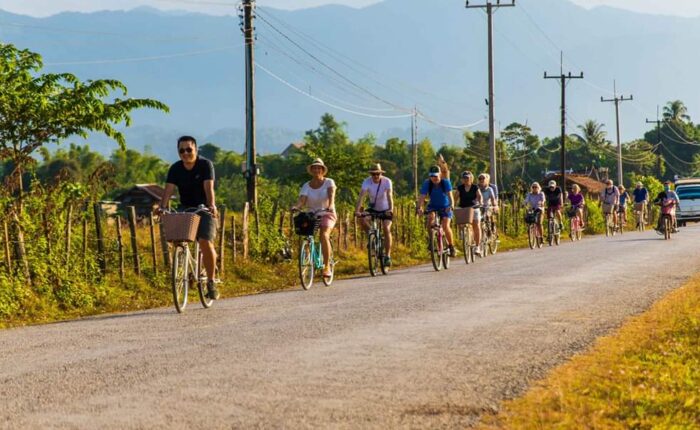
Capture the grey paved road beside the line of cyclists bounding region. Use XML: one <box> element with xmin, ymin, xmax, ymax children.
<box><xmin>0</xmin><ymin>227</ymin><xmax>700</xmax><ymax>429</ymax></box>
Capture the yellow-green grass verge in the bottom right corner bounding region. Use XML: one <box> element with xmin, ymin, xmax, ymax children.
<box><xmin>479</xmin><ymin>276</ymin><xmax>700</xmax><ymax>429</ymax></box>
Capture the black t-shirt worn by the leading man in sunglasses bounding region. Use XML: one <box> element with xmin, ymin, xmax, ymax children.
<box><xmin>166</xmin><ymin>157</ymin><xmax>214</xmax><ymax>208</ymax></box>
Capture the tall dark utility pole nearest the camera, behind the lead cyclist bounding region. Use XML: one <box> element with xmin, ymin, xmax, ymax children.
<box><xmin>243</xmin><ymin>0</ymin><xmax>258</xmax><ymax>213</ymax></box>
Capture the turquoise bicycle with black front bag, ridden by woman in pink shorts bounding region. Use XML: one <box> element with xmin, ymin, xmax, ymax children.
<box><xmin>294</xmin><ymin>209</ymin><xmax>337</xmax><ymax>290</ymax></box>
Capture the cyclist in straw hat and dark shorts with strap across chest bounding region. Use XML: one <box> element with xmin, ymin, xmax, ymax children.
<box><xmin>355</xmin><ymin>163</ymin><xmax>394</xmax><ymax>267</ymax></box>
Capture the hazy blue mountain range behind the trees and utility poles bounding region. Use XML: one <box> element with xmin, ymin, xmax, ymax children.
<box><xmin>0</xmin><ymin>0</ymin><xmax>700</xmax><ymax>158</ymax></box>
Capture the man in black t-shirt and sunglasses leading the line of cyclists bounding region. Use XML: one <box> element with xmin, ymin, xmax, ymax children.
<box><xmin>157</xmin><ymin>136</ymin><xmax>219</xmax><ymax>300</ymax></box>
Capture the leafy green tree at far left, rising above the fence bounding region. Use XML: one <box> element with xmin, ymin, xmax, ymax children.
<box><xmin>0</xmin><ymin>44</ymin><xmax>168</xmax><ymax>207</ymax></box>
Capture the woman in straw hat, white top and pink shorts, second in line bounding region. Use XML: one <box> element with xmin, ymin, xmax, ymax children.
<box><xmin>292</xmin><ymin>158</ymin><xmax>337</xmax><ymax>278</ymax></box>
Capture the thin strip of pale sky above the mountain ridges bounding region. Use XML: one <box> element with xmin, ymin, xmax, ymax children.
<box><xmin>0</xmin><ymin>0</ymin><xmax>700</xmax><ymax>16</ymax></box>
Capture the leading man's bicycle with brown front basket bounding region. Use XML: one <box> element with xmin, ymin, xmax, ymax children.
<box><xmin>161</xmin><ymin>205</ymin><xmax>221</xmax><ymax>313</ymax></box>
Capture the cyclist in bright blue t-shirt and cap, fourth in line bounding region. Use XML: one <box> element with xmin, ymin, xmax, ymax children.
<box><xmin>416</xmin><ymin>166</ymin><xmax>455</xmax><ymax>257</ymax></box>
